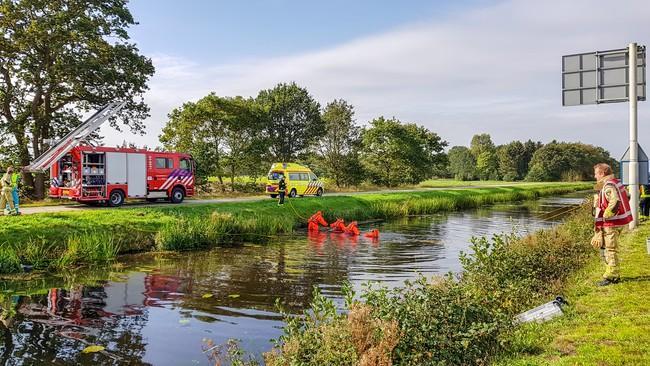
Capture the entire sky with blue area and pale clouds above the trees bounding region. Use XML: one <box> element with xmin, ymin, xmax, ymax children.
<box><xmin>102</xmin><ymin>0</ymin><xmax>650</xmax><ymax>157</ymax></box>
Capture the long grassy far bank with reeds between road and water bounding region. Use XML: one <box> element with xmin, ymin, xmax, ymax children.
<box><xmin>0</xmin><ymin>183</ymin><xmax>589</xmax><ymax>272</ymax></box>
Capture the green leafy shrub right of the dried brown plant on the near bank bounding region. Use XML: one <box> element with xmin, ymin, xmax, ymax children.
<box><xmin>363</xmin><ymin>276</ymin><xmax>508</xmax><ymax>365</ymax></box>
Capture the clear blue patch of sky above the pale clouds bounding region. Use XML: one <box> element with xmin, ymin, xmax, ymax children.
<box><xmin>129</xmin><ymin>0</ymin><xmax>486</xmax><ymax>63</ymax></box>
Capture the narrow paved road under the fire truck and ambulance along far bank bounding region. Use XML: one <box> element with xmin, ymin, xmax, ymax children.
<box><xmin>20</xmin><ymin>183</ymin><xmax>526</xmax><ymax>215</ymax></box>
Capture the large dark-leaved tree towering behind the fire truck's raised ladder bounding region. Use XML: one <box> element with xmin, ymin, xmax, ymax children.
<box><xmin>0</xmin><ymin>0</ymin><xmax>154</xmax><ymax>197</ymax></box>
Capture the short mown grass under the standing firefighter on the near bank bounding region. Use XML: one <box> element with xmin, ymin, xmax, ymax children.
<box><xmin>498</xmin><ymin>222</ymin><xmax>650</xmax><ymax>365</ymax></box>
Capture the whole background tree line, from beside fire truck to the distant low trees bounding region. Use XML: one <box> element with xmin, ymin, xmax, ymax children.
<box><xmin>160</xmin><ymin>83</ymin><xmax>617</xmax><ymax>187</ymax></box>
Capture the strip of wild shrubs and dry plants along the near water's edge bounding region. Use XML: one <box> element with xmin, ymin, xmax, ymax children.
<box><xmin>256</xmin><ymin>190</ymin><xmax>596</xmax><ymax>366</ymax></box>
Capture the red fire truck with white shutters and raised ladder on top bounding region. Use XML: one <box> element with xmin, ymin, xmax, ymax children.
<box><xmin>25</xmin><ymin>103</ymin><xmax>195</xmax><ymax>206</ymax></box>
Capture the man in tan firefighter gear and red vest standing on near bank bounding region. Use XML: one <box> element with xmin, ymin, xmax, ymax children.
<box><xmin>591</xmin><ymin>163</ymin><xmax>633</xmax><ymax>286</ymax></box>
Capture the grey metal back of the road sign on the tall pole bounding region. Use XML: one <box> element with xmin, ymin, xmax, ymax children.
<box><xmin>562</xmin><ymin>46</ymin><xmax>646</xmax><ymax>106</ymax></box>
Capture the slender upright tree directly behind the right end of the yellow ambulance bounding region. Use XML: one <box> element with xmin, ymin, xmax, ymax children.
<box><xmin>317</xmin><ymin>99</ymin><xmax>361</xmax><ymax>187</ymax></box>
